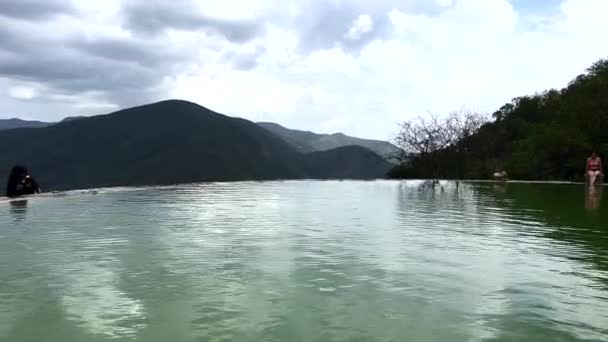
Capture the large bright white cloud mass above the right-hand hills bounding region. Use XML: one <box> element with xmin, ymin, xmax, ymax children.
<box><xmin>160</xmin><ymin>0</ymin><xmax>608</xmax><ymax>138</ymax></box>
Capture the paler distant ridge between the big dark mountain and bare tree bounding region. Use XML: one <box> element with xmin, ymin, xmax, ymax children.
<box><xmin>257</xmin><ymin>122</ymin><xmax>400</xmax><ymax>160</ymax></box>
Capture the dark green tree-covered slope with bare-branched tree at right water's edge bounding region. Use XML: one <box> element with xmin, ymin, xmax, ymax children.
<box><xmin>389</xmin><ymin>60</ymin><xmax>608</xmax><ymax>180</ymax></box>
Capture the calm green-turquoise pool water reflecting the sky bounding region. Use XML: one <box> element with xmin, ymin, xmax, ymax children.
<box><xmin>0</xmin><ymin>181</ymin><xmax>608</xmax><ymax>342</ymax></box>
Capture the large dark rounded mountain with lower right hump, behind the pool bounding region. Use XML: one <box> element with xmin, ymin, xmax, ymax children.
<box><xmin>0</xmin><ymin>100</ymin><xmax>391</xmax><ymax>190</ymax></box>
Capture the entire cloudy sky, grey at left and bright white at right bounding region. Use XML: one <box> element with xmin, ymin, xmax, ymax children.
<box><xmin>0</xmin><ymin>0</ymin><xmax>608</xmax><ymax>140</ymax></box>
